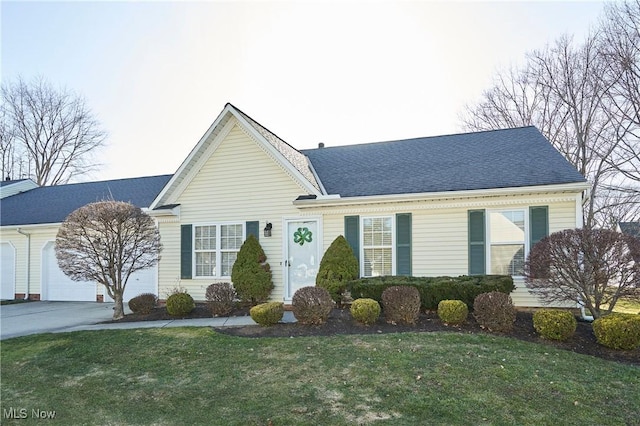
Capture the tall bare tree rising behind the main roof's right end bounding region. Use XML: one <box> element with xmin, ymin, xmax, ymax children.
<box><xmin>462</xmin><ymin>17</ymin><xmax>640</xmax><ymax>226</ymax></box>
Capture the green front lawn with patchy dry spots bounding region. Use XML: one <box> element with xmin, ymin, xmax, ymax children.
<box><xmin>0</xmin><ymin>328</ymin><xmax>640</xmax><ymax>425</ymax></box>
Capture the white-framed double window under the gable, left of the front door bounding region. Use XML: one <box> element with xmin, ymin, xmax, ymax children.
<box><xmin>194</xmin><ymin>224</ymin><xmax>244</xmax><ymax>277</ymax></box>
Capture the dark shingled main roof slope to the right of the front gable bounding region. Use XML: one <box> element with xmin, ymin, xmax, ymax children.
<box><xmin>302</xmin><ymin>126</ymin><xmax>586</xmax><ymax>197</ymax></box>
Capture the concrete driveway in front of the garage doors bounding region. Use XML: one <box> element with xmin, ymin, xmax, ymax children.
<box><xmin>0</xmin><ymin>302</ymin><xmax>128</xmax><ymax>339</ymax></box>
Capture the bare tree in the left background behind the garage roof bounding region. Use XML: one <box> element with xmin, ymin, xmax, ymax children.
<box><xmin>0</xmin><ymin>78</ymin><xmax>106</xmax><ymax>185</ymax></box>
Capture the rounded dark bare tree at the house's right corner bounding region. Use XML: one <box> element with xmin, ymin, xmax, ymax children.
<box><xmin>524</xmin><ymin>228</ymin><xmax>640</xmax><ymax>318</ymax></box>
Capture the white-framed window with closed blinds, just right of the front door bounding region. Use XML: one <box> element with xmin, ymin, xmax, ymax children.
<box><xmin>362</xmin><ymin>216</ymin><xmax>393</xmax><ymax>277</ymax></box>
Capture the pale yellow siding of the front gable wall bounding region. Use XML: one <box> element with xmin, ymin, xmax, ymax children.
<box><xmin>160</xmin><ymin>125</ymin><xmax>305</xmax><ymax>300</ymax></box>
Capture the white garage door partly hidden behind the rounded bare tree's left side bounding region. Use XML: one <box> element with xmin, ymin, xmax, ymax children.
<box><xmin>41</xmin><ymin>242</ymin><xmax>96</xmax><ymax>302</ymax></box>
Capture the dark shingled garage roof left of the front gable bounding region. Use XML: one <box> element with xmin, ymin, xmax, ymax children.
<box><xmin>0</xmin><ymin>175</ymin><xmax>172</xmax><ymax>226</ymax></box>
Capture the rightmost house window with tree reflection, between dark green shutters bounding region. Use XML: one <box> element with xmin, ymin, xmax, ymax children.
<box><xmin>488</xmin><ymin>210</ymin><xmax>527</xmax><ymax>275</ymax></box>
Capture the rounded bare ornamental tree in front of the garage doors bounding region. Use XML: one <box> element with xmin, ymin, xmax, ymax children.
<box><xmin>55</xmin><ymin>201</ymin><xmax>162</xmax><ymax>319</ymax></box>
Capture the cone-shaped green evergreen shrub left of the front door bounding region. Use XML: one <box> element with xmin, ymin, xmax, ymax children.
<box><xmin>231</xmin><ymin>235</ymin><xmax>273</xmax><ymax>305</ymax></box>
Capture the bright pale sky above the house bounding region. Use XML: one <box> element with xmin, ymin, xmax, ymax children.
<box><xmin>0</xmin><ymin>0</ymin><xmax>604</xmax><ymax>181</ymax></box>
